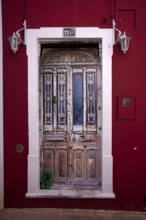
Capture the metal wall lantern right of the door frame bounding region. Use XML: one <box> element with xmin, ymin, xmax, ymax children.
<box><xmin>113</xmin><ymin>20</ymin><xmax>131</xmax><ymax>53</ymax></box>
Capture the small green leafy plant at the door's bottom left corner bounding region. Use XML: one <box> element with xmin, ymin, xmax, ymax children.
<box><xmin>40</xmin><ymin>169</ymin><xmax>53</xmax><ymax>189</ymax></box>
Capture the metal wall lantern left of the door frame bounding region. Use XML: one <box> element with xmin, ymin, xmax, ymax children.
<box><xmin>8</xmin><ymin>21</ymin><xmax>26</xmax><ymax>53</ymax></box>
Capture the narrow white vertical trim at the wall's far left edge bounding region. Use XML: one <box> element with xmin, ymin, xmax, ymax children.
<box><xmin>0</xmin><ymin>0</ymin><xmax>4</xmax><ymax>209</ymax></box>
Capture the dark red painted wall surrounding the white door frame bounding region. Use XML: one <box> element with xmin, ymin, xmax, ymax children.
<box><xmin>2</xmin><ymin>0</ymin><xmax>146</xmax><ymax>211</ymax></box>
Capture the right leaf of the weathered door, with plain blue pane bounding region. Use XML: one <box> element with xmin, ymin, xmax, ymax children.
<box><xmin>73</xmin><ymin>66</ymin><xmax>100</xmax><ymax>189</ymax></box>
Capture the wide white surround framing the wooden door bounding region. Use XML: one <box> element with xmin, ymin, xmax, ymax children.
<box><xmin>26</xmin><ymin>27</ymin><xmax>115</xmax><ymax>198</ymax></box>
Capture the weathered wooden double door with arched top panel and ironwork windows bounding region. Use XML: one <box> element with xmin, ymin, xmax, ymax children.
<box><xmin>40</xmin><ymin>48</ymin><xmax>101</xmax><ymax>189</ymax></box>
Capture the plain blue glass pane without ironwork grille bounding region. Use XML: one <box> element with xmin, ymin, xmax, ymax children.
<box><xmin>73</xmin><ymin>73</ymin><xmax>83</xmax><ymax>125</ymax></box>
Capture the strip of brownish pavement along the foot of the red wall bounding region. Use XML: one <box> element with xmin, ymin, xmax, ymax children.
<box><xmin>0</xmin><ymin>208</ymin><xmax>146</xmax><ymax>220</ymax></box>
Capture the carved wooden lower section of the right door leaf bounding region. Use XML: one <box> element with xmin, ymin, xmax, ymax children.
<box><xmin>73</xmin><ymin>142</ymin><xmax>101</xmax><ymax>189</ymax></box>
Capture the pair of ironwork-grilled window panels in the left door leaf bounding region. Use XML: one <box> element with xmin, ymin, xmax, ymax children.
<box><xmin>43</xmin><ymin>68</ymin><xmax>67</xmax><ymax>132</ymax></box>
